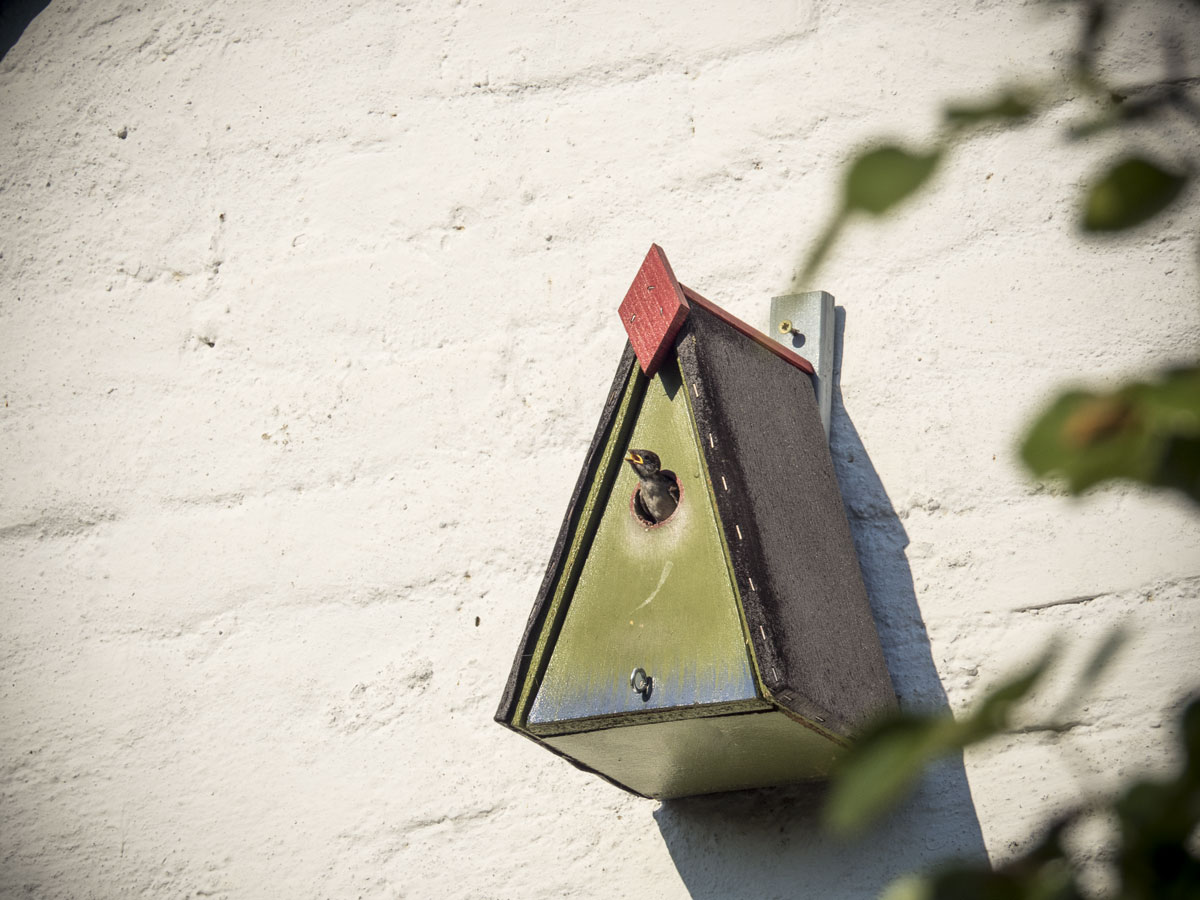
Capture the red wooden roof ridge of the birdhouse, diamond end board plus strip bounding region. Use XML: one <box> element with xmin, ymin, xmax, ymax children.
<box><xmin>618</xmin><ymin>244</ymin><xmax>816</xmax><ymax>376</ymax></box>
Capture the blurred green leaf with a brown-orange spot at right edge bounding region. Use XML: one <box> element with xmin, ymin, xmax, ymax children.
<box><xmin>1021</xmin><ymin>366</ymin><xmax>1200</xmax><ymax>502</ymax></box>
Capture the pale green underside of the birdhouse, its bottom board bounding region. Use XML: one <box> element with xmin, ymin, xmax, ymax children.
<box><xmin>544</xmin><ymin>710</ymin><xmax>841</xmax><ymax>799</ymax></box>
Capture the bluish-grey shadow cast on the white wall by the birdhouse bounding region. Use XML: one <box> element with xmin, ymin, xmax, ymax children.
<box><xmin>654</xmin><ymin>307</ymin><xmax>986</xmax><ymax>900</ymax></box>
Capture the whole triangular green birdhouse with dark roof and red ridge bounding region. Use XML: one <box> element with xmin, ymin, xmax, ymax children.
<box><xmin>496</xmin><ymin>245</ymin><xmax>895</xmax><ymax>798</ymax></box>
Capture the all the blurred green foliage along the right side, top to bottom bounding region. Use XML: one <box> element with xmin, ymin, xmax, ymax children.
<box><xmin>806</xmin><ymin>0</ymin><xmax>1200</xmax><ymax>900</ymax></box>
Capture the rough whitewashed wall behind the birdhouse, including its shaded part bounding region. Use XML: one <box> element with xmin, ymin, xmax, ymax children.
<box><xmin>0</xmin><ymin>0</ymin><xmax>1200</xmax><ymax>898</ymax></box>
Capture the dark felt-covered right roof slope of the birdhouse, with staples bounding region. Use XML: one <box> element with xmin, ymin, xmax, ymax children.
<box><xmin>677</xmin><ymin>306</ymin><xmax>895</xmax><ymax>738</ymax></box>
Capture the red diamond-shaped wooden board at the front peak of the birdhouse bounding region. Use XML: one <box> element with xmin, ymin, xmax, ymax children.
<box><xmin>618</xmin><ymin>244</ymin><xmax>688</xmax><ymax>376</ymax></box>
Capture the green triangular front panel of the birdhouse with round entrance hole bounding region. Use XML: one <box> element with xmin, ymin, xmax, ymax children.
<box><xmin>526</xmin><ymin>365</ymin><xmax>768</xmax><ymax>734</ymax></box>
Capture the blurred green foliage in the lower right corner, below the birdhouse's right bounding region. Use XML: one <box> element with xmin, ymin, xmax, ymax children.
<box><xmin>824</xmin><ymin>632</ymin><xmax>1200</xmax><ymax>900</ymax></box>
